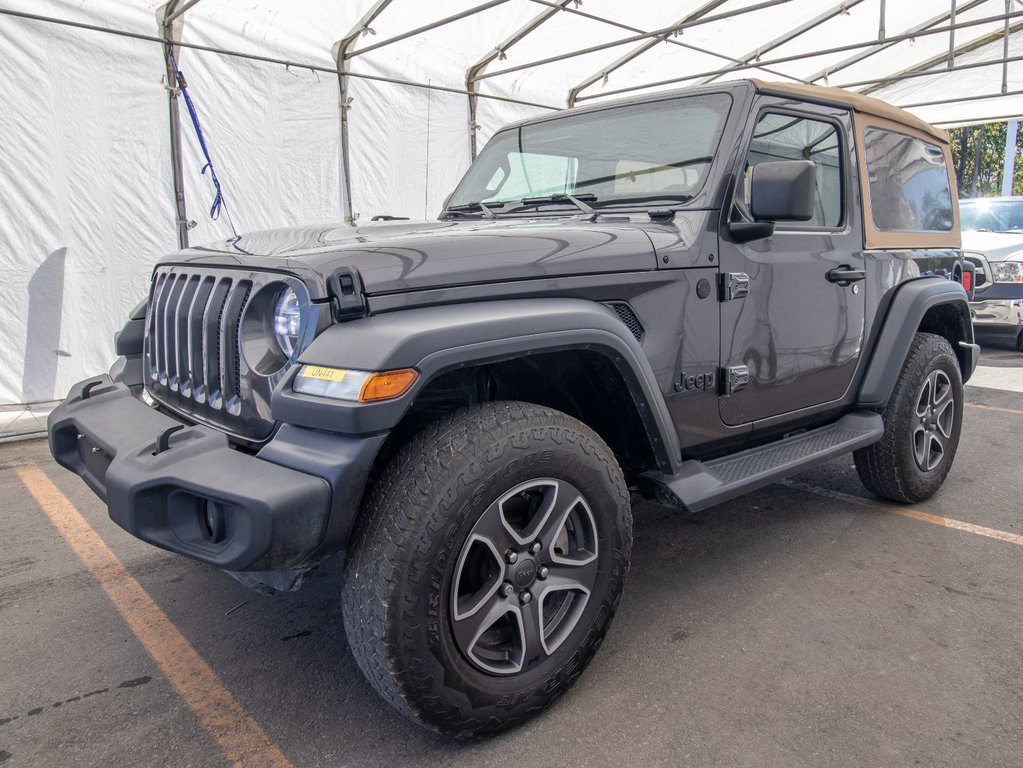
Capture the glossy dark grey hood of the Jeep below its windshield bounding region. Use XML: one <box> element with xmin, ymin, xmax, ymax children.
<box><xmin>180</xmin><ymin>217</ymin><xmax>657</xmax><ymax>296</ymax></box>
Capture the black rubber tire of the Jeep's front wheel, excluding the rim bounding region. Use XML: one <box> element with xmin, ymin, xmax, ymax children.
<box><xmin>343</xmin><ymin>402</ymin><xmax>632</xmax><ymax>737</ymax></box>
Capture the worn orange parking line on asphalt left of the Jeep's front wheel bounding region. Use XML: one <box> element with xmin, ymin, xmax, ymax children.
<box><xmin>14</xmin><ymin>466</ymin><xmax>292</xmax><ymax>768</ymax></box>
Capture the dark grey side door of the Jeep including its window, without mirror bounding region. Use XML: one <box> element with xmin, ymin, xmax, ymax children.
<box><xmin>718</xmin><ymin>98</ymin><xmax>864</xmax><ymax>425</ymax></box>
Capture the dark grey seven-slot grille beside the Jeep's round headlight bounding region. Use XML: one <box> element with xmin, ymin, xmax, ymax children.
<box><xmin>145</xmin><ymin>267</ymin><xmax>273</xmax><ymax>440</ymax></box>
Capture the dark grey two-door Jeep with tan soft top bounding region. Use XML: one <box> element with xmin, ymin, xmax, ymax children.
<box><xmin>49</xmin><ymin>81</ymin><xmax>978</xmax><ymax>736</ymax></box>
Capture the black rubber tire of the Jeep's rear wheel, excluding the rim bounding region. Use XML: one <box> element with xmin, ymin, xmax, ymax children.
<box><xmin>853</xmin><ymin>333</ymin><xmax>963</xmax><ymax>503</ymax></box>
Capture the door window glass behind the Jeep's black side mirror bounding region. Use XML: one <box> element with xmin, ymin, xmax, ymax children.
<box><xmin>742</xmin><ymin>112</ymin><xmax>843</xmax><ymax>229</ymax></box>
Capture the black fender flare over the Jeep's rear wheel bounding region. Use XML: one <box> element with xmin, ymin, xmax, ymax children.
<box><xmin>856</xmin><ymin>277</ymin><xmax>978</xmax><ymax>408</ymax></box>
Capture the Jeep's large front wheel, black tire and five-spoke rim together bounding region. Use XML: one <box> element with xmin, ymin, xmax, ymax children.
<box><xmin>344</xmin><ymin>402</ymin><xmax>631</xmax><ymax>736</ymax></box>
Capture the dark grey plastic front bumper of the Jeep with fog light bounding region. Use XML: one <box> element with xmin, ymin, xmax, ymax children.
<box><xmin>48</xmin><ymin>375</ymin><xmax>386</xmax><ymax>572</ymax></box>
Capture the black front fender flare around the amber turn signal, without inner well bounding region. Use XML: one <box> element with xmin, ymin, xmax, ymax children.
<box><xmin>271</xmin><ymin>299</ymin><xmax>680</xmax><ymax>471</ymax></box>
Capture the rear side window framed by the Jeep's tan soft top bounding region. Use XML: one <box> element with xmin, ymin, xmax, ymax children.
<box><xmin>863</xmin><ymin>127</ymin><xmax>952</xmax><ymax>232</ymax></box>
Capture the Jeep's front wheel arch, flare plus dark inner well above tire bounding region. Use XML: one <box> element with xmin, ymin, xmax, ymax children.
<box><xmin>272</xmin><ymin>299</ymin><xmax>679</xmax><ymax>471</ymax></box>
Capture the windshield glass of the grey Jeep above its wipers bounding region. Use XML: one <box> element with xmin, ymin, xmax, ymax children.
<box><xmin>448</xmin><ymin>93</ymin><xmax>731</xmax><ymax>213</ymax></box>
